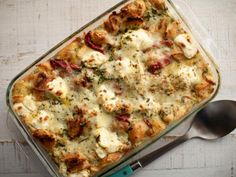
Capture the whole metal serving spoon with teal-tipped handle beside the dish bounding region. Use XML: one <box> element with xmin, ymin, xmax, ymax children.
<box><xmin>110</xmin><ymin>100</ymin><xmax>236</xmax><ymax>177</ymax></box>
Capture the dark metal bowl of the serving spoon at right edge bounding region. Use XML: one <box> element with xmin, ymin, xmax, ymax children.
<box><xmin>187</xmin><ymin>100</ymin><xmax>236</xmax><ymax>140</ymax></box>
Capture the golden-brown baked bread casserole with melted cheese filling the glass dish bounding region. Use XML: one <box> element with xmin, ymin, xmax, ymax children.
<box><xmin>12</xmin><ymin>0</ymin><xmax>215</xmax><ymax>177</ymax></box>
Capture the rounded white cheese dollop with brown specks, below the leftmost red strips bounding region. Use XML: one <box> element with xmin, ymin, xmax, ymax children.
<box><xmin>47</xmin><ymin>76</ymin><xmax>68</xmax><ymax>98</ymax></box>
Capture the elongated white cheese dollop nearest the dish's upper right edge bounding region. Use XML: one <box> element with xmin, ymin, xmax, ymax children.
<box><xmin>175</xmin><ymin>34</ymin><xmax>198</xmax><ymax>59</ymax></box>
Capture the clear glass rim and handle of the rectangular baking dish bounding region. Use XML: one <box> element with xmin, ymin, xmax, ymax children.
<box><xmin>6</xmin><ymin>0</ymin><xmax>220</xmax><ymax>177</ymax></box>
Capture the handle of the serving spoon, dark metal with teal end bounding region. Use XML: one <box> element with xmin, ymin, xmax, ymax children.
<box><xmin>109</xmin><ymin>134</ymin><xmax>189</xmax><ymax>177</ymax></box>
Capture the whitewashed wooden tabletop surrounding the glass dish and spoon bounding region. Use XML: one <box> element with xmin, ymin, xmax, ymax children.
<box><xmin>0</xmin><ymin>0</ymin><xmax>236</xmax><ymax>177</ymax></box>
